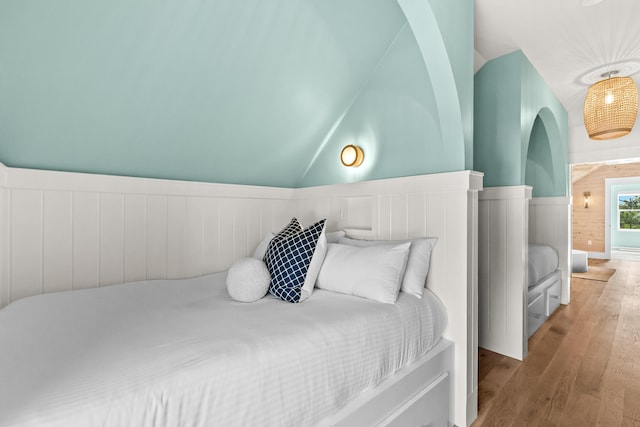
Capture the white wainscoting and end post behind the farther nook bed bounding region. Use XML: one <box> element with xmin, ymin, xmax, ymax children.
<box><xmin>529</xmin><ymin>197</ymin><xmax>571</xmax><ymax>304</ymax></box>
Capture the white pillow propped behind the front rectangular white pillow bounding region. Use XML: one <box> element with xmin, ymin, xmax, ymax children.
<box><xmin>338</xmin><ymin>237</ymin><xmax>438</xmax><ymax>298</ymax></box>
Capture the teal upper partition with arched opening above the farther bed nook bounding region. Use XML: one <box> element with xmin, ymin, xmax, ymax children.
<box><xmin>473</xmin><ymin>51</ymin><xmax>569</xmax><ymax>197</ymax></box>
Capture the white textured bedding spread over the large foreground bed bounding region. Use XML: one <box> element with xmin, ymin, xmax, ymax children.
<box><xmin>0</xmin><ymin>273</ymin><xmax>446</xmax><ymax>427</ymax></box>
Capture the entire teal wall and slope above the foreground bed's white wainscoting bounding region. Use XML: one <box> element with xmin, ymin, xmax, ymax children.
<box><xmin>0</xmin><ymin>0</ymin><xmax>473</xmax><ymax>187</ymax></box>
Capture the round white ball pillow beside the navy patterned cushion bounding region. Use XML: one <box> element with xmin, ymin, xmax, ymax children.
<box><xmin>227</xmin><ymin>258</ymin><xmax>271</xmax><ymax>302</ymax></box>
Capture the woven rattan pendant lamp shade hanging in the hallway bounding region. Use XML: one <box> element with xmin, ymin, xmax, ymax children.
<box><xmin>584</xmin><ymin>77</ymin><xmax>638</xmax><ymax>139</ymax></box>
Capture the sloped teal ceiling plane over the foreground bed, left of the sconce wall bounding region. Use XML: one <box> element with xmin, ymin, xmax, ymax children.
<box><xmin>0</xmin><ymin>0</ymin><xmax>410</xmax><ymax>186</ymax></box>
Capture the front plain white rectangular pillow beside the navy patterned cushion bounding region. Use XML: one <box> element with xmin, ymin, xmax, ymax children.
<box><xmin>316</xmin><ymin>242</ymin><xmax>411</xmax><ymax>304</ymax></box>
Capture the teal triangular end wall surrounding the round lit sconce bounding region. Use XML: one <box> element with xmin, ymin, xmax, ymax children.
<box><xmin>299</xmin><ymin>0</ymin><xmax>473</xmax><ymax>186</ymax></box>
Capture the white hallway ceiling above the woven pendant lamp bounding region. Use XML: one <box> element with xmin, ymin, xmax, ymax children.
<box><xmin>475</xmin><ymin>0</ymin><xmax>640</xmax><ymax>128</ymax></box>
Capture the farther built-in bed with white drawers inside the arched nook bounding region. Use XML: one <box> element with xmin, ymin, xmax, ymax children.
<box><xmin>527</xmin><ymin>244</ymin><xmax>562</xmax><ymax>338</ymax></box>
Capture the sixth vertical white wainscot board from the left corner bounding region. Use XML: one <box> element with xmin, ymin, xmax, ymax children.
<box><xmin>146</xmin><ymin>195</ymin><xmax>169</xmax><ymax>279</ymax></box>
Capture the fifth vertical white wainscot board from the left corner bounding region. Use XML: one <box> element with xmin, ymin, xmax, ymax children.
<box><xmin>124</xmin><ymin>194</ymin><xmax>148</xmax><ymax>282</ymax></box>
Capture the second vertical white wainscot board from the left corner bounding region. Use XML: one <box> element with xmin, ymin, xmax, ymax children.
<box><xmin>42</xmin><ymin>191</ymin><xmax>73</xmax><ymax>292</ymax></box>
